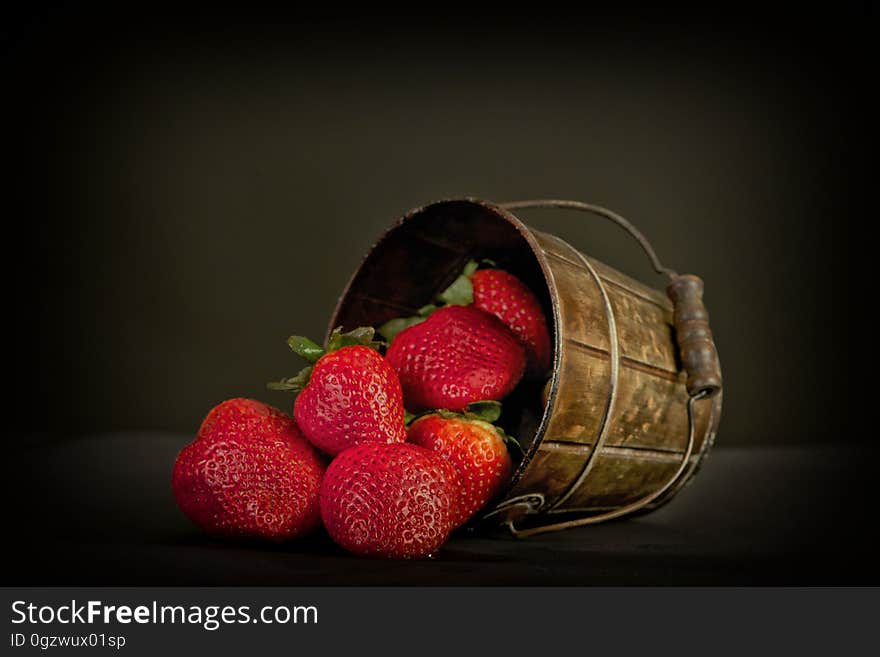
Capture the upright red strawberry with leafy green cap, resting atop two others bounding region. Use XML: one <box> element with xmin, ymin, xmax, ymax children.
<box><xmin>270</xmin><ymin>329</ymin><xmax>406</xmax><ymax>454</ymax></box>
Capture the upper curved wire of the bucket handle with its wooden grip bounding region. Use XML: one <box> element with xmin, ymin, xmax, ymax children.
<box><xmin>499</xmin><ymin>199</ymin><xmax>722</xmax><ymax>398</ymax></box>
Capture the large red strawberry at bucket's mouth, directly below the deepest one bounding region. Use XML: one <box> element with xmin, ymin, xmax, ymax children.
<box><xmin>385</xmin><ymin>306</ymin><xmax>526</xmax><ymax>411</ymax></box>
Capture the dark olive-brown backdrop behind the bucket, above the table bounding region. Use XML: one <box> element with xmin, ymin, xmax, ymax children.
<box><xmin>4</xmin><ymin>3</ymin><xmax>871</xmax><ymax>445</ymax></box>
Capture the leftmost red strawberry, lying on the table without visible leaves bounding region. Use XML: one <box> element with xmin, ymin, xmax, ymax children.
<box><xmin>172</xmin><ymin>399</ymin><xmax>324</xmax><ymax>541</ymax></box>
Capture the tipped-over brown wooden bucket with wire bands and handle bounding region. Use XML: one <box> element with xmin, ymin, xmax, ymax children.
<box><xmin>328</xmin><ymin>199</ymin><xmax>721</xmax><ymax>536</ymax></box>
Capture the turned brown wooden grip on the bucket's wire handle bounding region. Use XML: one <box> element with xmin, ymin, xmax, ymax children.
<box><xmin>666</xmin><ymin>274</ymin><xmax>721</xmax><ymax>397</ymax></box>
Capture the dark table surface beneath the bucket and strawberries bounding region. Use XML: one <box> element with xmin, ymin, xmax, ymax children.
<box><xmin>3</xmin><ymin>433</ymin><xmax>880</xmax><ymax>585</ymax></box>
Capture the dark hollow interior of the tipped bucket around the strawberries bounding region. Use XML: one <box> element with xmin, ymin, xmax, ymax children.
<box><xmin>329</xmin><ymin>201</ymin><xmax>556</xmax><ymax>462</ymax></box>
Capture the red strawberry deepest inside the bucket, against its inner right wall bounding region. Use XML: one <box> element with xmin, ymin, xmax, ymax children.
<box><xmin>470</xmin><ymin>269</ymin><xmax>553</xmax><ymax>379</ymax></box>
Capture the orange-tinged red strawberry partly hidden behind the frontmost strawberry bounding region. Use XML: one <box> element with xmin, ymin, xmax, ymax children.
<box><xmin>408</xmin><ymin>402</ymin><xmax>513</xmax><ymax>526</ymax></box>
